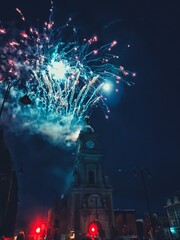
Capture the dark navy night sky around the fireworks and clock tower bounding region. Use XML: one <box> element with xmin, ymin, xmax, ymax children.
<box><xmin>0</xmin><ymin>0</ymin><xmax>180</xmax><ymax>227</ymax></box>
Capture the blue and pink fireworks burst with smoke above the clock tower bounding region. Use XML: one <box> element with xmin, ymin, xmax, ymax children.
<box><xmin>0</xmin><ymin>8</ymin><xmax>135</xmax><ymax>147</ymax></box>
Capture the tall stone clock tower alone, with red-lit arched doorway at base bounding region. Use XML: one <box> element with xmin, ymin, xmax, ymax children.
<box><xmin>69</xmin><ymin>118</ymin><xmax>114</xmax><ymax>239</ymax></box>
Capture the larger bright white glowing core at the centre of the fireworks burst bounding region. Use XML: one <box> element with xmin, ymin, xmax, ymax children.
<box><xmin>48</xmin><ymin>61</ymin><xmax>68</xmax><ymax>79</ymax></box>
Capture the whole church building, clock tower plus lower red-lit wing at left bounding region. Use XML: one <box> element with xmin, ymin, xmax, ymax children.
<box><xmin>47</xmin><ymin>118</ymin><xmax>114</xmax><ymax>240</ymax></box>
